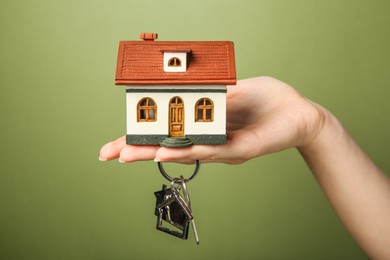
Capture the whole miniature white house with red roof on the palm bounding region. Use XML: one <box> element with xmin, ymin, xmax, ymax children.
<box><xmin>115</xmin><ymin>33</ymin><xmax>236</xmax><ymax>147</ymax></box>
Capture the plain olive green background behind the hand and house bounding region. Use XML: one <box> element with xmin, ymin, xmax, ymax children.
<box><xmin>0</xmin><ymin>0</ymin><xmax>390</xmax><ymax>259</ymax></box>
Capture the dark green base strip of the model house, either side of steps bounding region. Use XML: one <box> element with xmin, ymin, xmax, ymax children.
<box><xmin>126</xmin><ymin>135</ymin><xmax>227</xmax><ymax>145</ymax></box>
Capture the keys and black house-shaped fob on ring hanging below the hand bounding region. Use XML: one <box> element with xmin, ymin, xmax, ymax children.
<box><xmin>154</xmin><ymin>160</ymin><xmax>200</xmax><ymax>244</ymax></box>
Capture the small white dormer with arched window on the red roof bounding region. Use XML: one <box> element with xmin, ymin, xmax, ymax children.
<box><xmin>161</xmin><ymin>50</ymin><xmax>191</xmax><ymax>72</ymax></box>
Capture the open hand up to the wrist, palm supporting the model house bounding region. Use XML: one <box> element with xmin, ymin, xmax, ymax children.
<box><xmin>99</xmin><ymin>77</ymin><xmax>326</xmax><ymax>164</ymax></box>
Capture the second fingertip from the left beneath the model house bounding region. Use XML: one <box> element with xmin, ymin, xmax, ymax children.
<box><xmin>119</xmin><ymin>145</ymin><xmax>160</xmax><ymax>162</ymax></box>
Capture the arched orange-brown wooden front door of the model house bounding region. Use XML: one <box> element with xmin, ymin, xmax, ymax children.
<box><xmin>169</xmin><ymin>97</ymin><xmax>184</xmax><ymax>136</ymax></box>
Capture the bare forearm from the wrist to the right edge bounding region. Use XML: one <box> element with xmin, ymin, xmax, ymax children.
<box><xmin>298</xmin><ymin>107</ymin><xmax>390</xmax><ymax>259</ymax></box>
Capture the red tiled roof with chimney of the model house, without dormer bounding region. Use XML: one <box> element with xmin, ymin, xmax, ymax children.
<box><xmin>115</xmin><ymin>34</ymin><xmax>236</xmax><ymax>85</ymax></box>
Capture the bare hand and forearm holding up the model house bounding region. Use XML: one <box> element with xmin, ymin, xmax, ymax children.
<box><xmin>99</xmin><ymin>77</ymin><xmax>390</xmax><ymax>259</ymax></box>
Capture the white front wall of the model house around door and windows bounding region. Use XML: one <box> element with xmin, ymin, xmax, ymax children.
<box><xmin>126</xmin><ymin>85</ymin><xmax>226</xmax><ymax>135</ymax></box>
